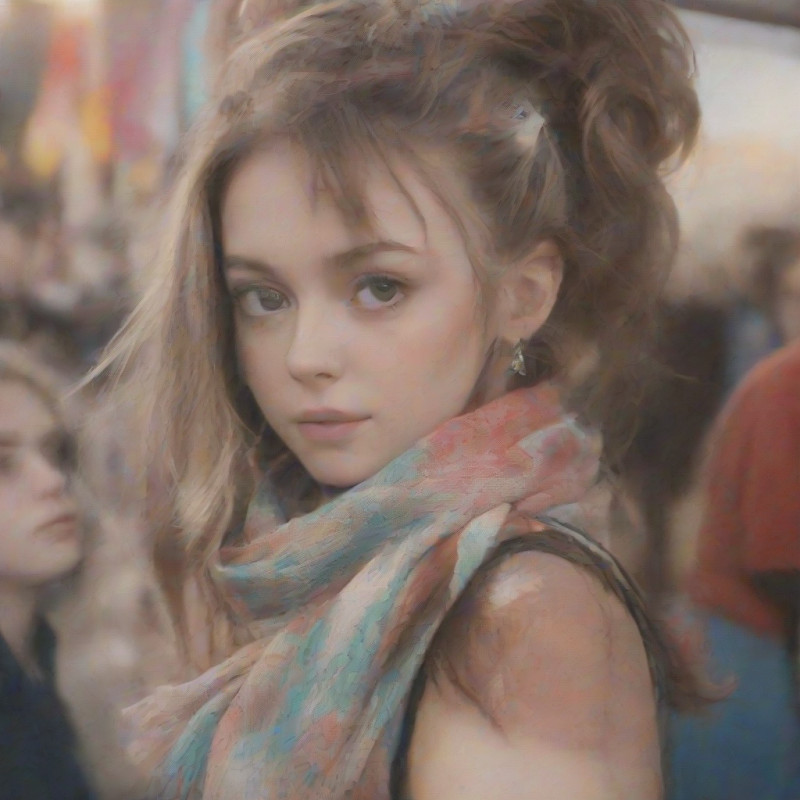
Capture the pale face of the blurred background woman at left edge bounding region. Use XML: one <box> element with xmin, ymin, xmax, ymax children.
<box><xmin>0</xmin><ymin>380</ymin><xmax>81</xmax><ymax>586</ymax></box>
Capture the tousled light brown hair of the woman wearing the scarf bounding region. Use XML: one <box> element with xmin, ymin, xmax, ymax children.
<box><xmin>101</xmin><ymin>0</ymin><xmax>699</xmax><ymax>656</ymax></box>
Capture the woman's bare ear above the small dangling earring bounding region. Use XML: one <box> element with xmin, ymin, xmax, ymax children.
<box><xmin>497</xmin><ymin>234</ymin><xmax>564</xmax><ymax>344</ymax></box>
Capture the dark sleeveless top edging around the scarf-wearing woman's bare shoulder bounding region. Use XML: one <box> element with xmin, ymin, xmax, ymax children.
<box><xmin>389</xmin><ymin>516</ymin><xmax>676</xmax><ymax>800</ymax></box>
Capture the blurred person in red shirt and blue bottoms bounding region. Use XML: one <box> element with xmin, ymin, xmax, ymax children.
<box><xmin>673</xmin><ymin>342</ymin><xmax>800</xmax><ymax>800</ymax></box>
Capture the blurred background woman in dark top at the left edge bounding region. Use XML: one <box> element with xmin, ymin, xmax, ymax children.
<box><xmin>0</xmin><ymin>343</ymin><xmax>93</xmax><ymax>800</ymax></box>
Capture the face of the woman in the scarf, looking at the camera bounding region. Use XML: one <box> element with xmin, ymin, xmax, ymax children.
<box><xmin>222</xmin><ymin>144</ymin><xmax>494</xmax><ymax>487</ymax></box>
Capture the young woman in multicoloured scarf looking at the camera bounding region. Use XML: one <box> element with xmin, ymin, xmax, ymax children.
<box><xmin>104</xmin><ymin>0</ymin><xmax>697</xmax><ymax>800</ymax></box>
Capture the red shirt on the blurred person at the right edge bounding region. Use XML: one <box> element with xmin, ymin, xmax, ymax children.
<box><xmin>690</xmin><ymin>343</ymin><xmax>800</xmax><ymax>638</ymax></box>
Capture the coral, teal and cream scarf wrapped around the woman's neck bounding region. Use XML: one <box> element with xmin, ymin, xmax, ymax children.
<box><xmin>128</xmin><ymin>386</ymin><xmax>597</xmax><ymax>800</ymax></box>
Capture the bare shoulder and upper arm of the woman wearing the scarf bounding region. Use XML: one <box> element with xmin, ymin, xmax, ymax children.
<box><xmin>409</xmin><ymin>552</ymin><xmax>661</xmax><ymax>800</ymax></box>
